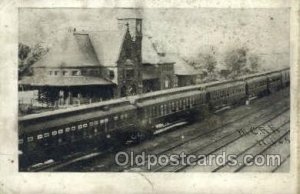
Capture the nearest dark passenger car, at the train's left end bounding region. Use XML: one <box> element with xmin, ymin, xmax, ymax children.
<box><xmin>19</xmin><ymin>98</ymin><xmax>136</xmax><ymax>167</ymax></box>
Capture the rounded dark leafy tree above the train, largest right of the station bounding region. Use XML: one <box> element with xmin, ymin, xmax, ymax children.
<box><xmin>224</xmin><ymin>47</ymin><xmax>248</xmax><ymax>76</ymax></box>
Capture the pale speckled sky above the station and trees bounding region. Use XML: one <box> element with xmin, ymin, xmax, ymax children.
<box><xmin>19</xmin><ymin>8</ymin><xmax>290</xmax><ymax>69</ymax></box>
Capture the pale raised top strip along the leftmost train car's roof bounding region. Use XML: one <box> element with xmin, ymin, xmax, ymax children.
<box><xmin>19</xmin><ymin>97</ymin><xmax>130</xmax><ymax>121</ymax></box>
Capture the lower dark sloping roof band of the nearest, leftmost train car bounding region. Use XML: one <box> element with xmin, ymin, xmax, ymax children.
<box><xmin>19</xmin><ymin>105</ymin><xmax>136</xmax><ymax>135</ymax></box>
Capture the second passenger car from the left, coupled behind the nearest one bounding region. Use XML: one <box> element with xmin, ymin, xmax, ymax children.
<box><xmin>135</xmin><ymin>86</ymin><xmax>206</xmax><ymax>136</ymax></box>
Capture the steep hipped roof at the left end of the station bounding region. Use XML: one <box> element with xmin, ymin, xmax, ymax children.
<box><xmin>33</xmin><ymin>32</ymin><xmax>100</xmax><ymax>67</ymax></box>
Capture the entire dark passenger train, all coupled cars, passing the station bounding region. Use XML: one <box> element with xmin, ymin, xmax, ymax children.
<box><xmin>19</xmin><ymin>69</ymin><xmax>289</xmax><ymax>165</ymax></box>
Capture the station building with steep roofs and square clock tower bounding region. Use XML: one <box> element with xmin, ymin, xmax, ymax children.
<box><xmin>19</xmin><ymin>12</ymin><xmax>194</xmax><ymax>105</ymax></box>
